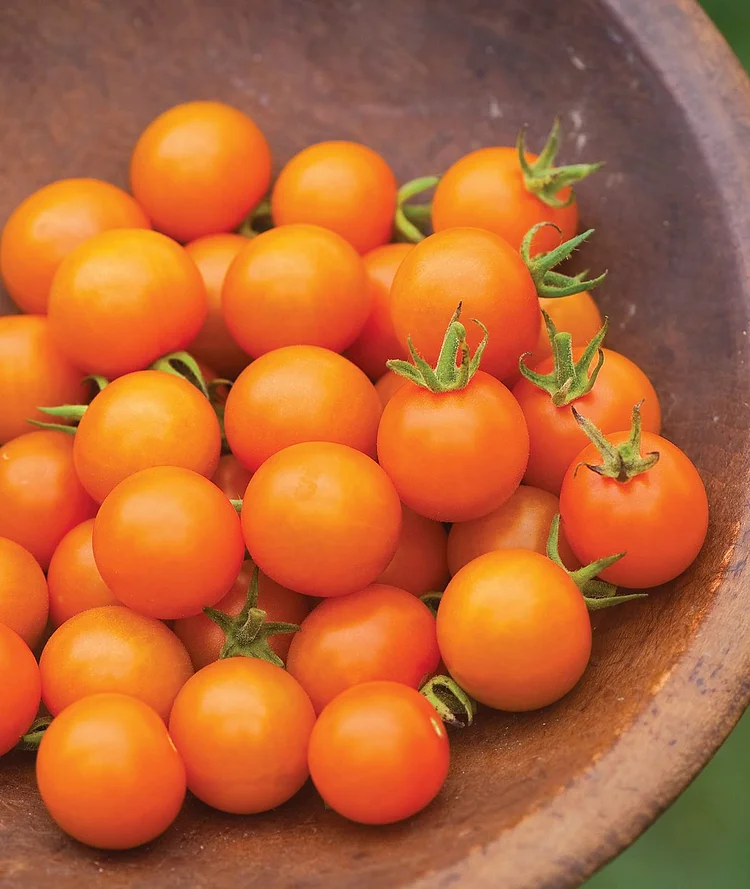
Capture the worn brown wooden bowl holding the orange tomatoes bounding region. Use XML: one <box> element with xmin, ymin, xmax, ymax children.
<box><xmin>0</xmin><ymin>0</ymin><xmax>750</xmax><ymax>889</ymax></box>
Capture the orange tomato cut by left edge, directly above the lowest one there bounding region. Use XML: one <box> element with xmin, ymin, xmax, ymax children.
<box><xmin>0</xmin><ymin>537</ymin><xmax>49</xmax><ymax>648</ymax></box>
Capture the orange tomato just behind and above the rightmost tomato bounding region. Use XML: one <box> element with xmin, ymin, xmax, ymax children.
<box><xmin>513</xmin><ymin>347</ymin><xmax>661</xmax><ymax>492</ymax></box>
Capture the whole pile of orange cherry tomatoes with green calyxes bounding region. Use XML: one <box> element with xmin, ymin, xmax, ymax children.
<box><xmin>0</xmin><ymin>102</ymin><xmax>708</xmax><ymax>849</ymax></box>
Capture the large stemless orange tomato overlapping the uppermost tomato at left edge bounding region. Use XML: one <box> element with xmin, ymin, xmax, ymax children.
<box><xmin>49</xmin><ymin>229</ymin><xmax>206</xmax><ymax>377</ymax></box>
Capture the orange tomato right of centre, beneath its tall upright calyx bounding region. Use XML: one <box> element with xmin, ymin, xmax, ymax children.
<box><xmin>378</xmin><ymin>371</ymin><xmax>529</xmax><ymax>522</ymax></box>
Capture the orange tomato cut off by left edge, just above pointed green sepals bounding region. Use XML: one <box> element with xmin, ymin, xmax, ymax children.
<box><xmin>0</xmin><ymin>315</ymin><xmax>86</xmax><ymax>443</ymax></box>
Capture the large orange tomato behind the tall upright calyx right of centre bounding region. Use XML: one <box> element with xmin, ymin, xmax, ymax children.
<box><xmin>391</xmin><ymin>228</ymin><xmax>541</xmax><ymax>380</ymax></box>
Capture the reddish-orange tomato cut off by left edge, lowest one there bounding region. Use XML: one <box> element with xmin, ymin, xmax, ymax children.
<box><xmin>0</xmin><ymin>623</ymin><xmax>42</xmax><ymax>756</ymax></box>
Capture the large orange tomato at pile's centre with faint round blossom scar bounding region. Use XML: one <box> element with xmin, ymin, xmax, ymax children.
<box><xmin>242</xmin><ymin>442</ymin><xmax>401</xmax><ymax>596</ymax></box>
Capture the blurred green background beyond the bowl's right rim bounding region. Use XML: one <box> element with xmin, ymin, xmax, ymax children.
<box><xmin>585</xmin><ymin>0</ymin><xmax>750</xmax><ymax>889</ymax></box>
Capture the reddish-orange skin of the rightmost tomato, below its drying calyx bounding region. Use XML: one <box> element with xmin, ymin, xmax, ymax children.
<box><xmin>560</xmin><ymin>432</ymin><xmax>708</xmax><ymax>589</ymax></box>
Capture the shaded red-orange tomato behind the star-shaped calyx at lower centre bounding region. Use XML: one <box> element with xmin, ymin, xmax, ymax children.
<box><xmin>174</xmin><ymin>560</ymin><xmax>313</xmax><ymax>670</ymax></box>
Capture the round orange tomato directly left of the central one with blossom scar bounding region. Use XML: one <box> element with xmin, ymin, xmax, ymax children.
<box><xmin>93</xmin><ymin>466</ymin><xmax>245</xmax><ymax>620</ymax></box>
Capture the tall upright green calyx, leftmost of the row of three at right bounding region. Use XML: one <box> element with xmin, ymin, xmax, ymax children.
<box><xmin>386</xmin><ymin>303</ymin><xmax>489</xmax><ymax>392</ymax></box>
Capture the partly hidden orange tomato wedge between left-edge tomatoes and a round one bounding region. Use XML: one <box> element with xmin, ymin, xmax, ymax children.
<box><xmin>47</xmin><ymin>519</ymin><xmax>119</xmax><ymax>627</ymax></box>
